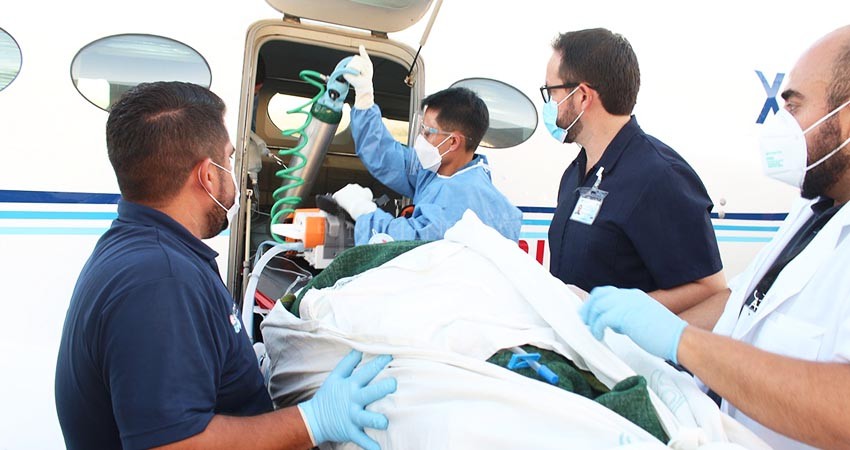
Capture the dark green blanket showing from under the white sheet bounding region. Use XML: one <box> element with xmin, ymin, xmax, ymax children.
<box><xmin>289</xmin><ymin>241</ymin><xmax>669</xmax><ymax>443</ymax></box>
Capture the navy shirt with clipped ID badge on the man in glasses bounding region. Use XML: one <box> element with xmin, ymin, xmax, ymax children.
<box><xmin>549</xmin><ymin>116</ymin><xmax>723</xmax><ymax>292</ymax></box>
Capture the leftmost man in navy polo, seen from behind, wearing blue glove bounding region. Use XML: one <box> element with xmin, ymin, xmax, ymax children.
<box><xmin>55</xmin><ymin>82</ymin><xmax>396</xmax><ymax>449</ymax></box>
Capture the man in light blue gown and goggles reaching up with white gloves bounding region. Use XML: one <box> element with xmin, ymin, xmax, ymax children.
<box><xmin>334</xmin><ymin>46</ymin><xmax>522</xmax><ymax>245</ymax></box>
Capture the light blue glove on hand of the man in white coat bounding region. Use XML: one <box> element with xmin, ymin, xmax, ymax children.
<box><xmin>579</xmin><ymin>286</ymin><xmax>687</xmax><ymax>364</ymax></box>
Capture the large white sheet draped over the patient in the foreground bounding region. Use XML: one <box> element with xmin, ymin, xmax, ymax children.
<box><xmin>262</xmin><ymin>211</ymin><xmax>768</xmax><ymax>450</ymax></box>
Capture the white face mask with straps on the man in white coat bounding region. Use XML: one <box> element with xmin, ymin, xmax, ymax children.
<box><xmin>759</xmin><ymin>100</ymin><xmax>850</xmax><ymax>189</ymax></box>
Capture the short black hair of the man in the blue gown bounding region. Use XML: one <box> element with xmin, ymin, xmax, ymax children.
<box><xmin>422</xmin><ymin>87</ymin><xmax>490</xmax><ymax>151</ymax></box>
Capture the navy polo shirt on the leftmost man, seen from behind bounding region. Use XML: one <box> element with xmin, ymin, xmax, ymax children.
<box><xmin>55</xmin><ymin>200</ymin><xmax>272</xmax><ymax>449</ymax></box>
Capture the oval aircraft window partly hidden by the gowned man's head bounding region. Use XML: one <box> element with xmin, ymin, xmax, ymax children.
<box><xmin>452</xmin><ymin>78</ymin><xmax>537</xmax><ymax>148</ymax></box>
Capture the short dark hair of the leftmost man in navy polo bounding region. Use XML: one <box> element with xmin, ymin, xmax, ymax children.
<box><xmin>106</xmin><ymin>81</ymin><xmax>229</xmax><ymax>202</ymax></box>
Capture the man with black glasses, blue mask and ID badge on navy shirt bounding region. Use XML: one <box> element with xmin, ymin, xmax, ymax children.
<box><xmin>540</xmin><ymin>28</ymin><xmax>726</xmax><ymax>312</ymax></box>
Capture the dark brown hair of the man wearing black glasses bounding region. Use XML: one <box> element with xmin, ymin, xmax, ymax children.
<box><xmin>552</xmin><ymin>28</ymin><xmax>640</xmax><ymax>116</ymax></box>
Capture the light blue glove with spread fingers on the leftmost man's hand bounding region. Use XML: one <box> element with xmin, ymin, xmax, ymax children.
<box><xmin>298</xmin><ymin>350</ymin><xmax>396</xmax><ymax>450</ymax></box>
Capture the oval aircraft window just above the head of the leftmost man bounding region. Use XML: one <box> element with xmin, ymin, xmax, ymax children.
<box><xmin>71</xmin><ymin>34</ymin><xmax>212</xmax><ymax>110</ymax></box>
